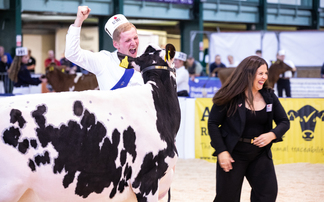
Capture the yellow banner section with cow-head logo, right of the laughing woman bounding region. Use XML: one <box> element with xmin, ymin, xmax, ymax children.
<box><xmin>272</xmin><ymin>98</ymin><xmax>324</xmax><ymax>164</ymax></box>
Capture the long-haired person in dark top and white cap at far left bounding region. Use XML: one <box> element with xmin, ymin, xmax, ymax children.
<box><xmin>8</xmin><ymin>47</ymin><xmax>47</xmax><ymax>94</ymax></box>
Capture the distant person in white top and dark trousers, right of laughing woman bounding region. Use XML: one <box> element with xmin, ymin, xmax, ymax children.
<box><xmin>277</xmin><ymin>50</ymin><xmax>296</xmax><ymax>97</ymax></box>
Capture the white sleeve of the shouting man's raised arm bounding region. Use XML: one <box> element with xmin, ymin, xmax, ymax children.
<box><xmin>65</xmin><ymin>25</ymin><xmax>110</xmax><ymax>74</ymax></box>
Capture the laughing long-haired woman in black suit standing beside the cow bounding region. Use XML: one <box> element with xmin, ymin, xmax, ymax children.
<box><xmin>208</xmin><ymin>56</ymin><xmax>290</xmax><ymax>202</ymax></box>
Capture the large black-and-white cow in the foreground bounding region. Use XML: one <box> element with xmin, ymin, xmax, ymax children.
<box><xmin>0</xmin><ymin>45</ymin><xmax>180</xmax><ymax>202</ymax></box>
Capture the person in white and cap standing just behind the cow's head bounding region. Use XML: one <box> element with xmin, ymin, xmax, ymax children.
<box><xmin>174</xmin><ymin>51</ymin><xmax>189</xmax><ymax>97</ymax></box>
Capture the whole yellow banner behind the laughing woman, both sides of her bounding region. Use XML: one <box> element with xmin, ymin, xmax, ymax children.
<box><xmin>195</xmin><ymin>98</ymin><xmax>324</xmax><ymax>164</ymax></box>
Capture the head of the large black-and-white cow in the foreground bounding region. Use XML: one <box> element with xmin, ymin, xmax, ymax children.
<box><xmin>118</xmin><ymin>44</ymin><xmax>175</xmax><ymax>72</ymax></box>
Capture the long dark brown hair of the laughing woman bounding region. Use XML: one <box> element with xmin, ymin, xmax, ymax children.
<box><xmin>213</xmin><ymin>55</ymin><xmax>270</xmax><ymax>116</ymax></box>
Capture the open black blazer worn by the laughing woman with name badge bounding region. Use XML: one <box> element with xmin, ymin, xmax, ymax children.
<box><xmin>208</xmin><ymin>89</ymin><xmax>290</xmax><ymax>158</ymax></box>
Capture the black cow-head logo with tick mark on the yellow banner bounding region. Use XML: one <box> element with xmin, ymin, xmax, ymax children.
<box><xmin>288</xmin><ymin>105</ymin><xmax>324</xmax><ymax>141</ymax></box>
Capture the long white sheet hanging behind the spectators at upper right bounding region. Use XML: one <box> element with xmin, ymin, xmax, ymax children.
<box><xmin>209</xmin><ymin>30</ymin><xmax>324</xmax><ymax>67</ymax></box>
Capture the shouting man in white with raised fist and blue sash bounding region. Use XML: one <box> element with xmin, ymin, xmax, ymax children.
<box><xmin>65</xmin><ymin>6</ymin><xmax>144</xmax><ymax>90</ymax></box>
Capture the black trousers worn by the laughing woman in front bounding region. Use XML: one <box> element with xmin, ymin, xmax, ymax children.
<box><xmin>214</xmin><ymin>142</ymin><xmax>278</xmax><ymax>202</ymax></box>
